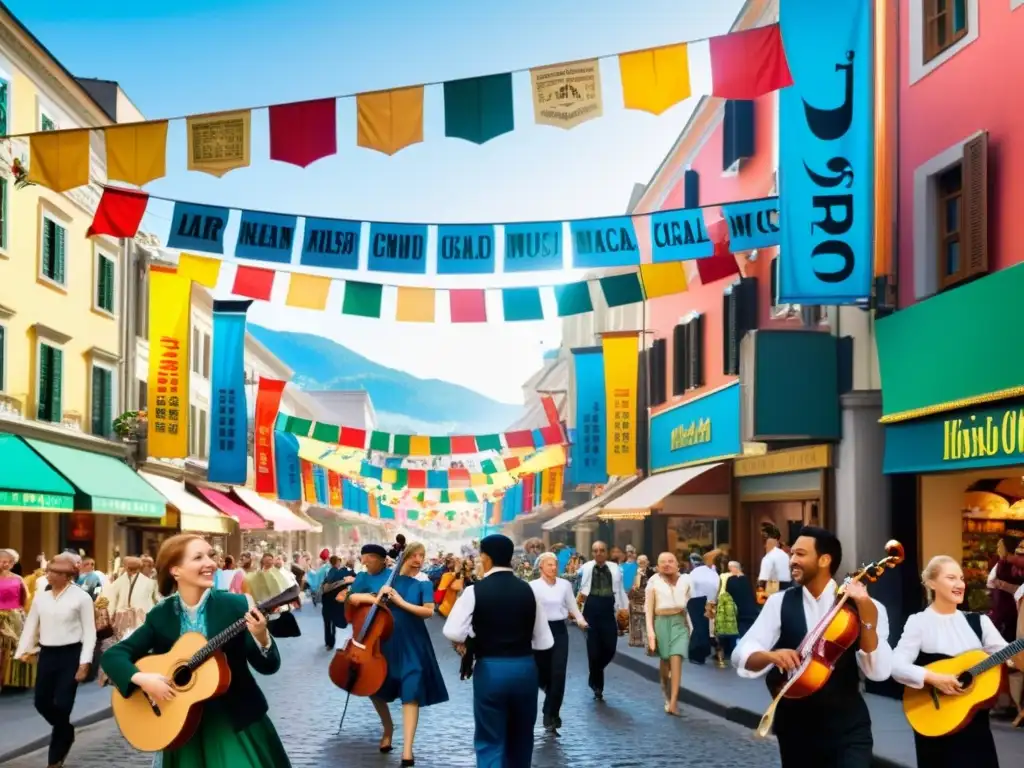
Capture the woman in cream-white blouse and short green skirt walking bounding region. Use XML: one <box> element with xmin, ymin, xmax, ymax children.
<box><xmin>644</xmin><ymin>552</ymin><xmax>692</xmax><ymax>717</ymax></box>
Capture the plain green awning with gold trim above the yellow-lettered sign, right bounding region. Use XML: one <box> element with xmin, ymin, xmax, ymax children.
<box><xmin>876</xmin><ymin>264</ymin><xmax>1024</xmax><ymax>423</ymax></box>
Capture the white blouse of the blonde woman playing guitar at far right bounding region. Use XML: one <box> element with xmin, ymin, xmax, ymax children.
<box><xmin>893</xmin><ymin>607</ymin><xmax>1007</xmax><ymax>688</ymax></box>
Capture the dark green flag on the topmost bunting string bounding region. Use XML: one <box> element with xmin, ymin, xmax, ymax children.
<box><xmin>444</xmin><ymin>72</ymin><xmax>515</xmax><ymax>144</ymax></box>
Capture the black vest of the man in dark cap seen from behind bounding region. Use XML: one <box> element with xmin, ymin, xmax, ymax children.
<box><xmin>473</xmin><ymin>570</ymin><xmax>537</xmax><ymax>658</ymax></box>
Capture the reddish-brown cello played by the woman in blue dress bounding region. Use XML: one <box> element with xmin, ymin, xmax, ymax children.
<box><xmin>328</xmin><ymin>552</ymin><xmax>404</xmax><ymax>730</ymax></box>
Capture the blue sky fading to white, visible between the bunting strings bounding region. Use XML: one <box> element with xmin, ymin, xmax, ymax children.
<box><xmin>6</xmin><ymin>0</ymin><xmax>742</xmax><ymax>405</ymax></box>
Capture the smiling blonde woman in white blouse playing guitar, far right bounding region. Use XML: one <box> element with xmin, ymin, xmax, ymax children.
<box><xmin>893</xmin><ymin>555</ymin><xmax>1007</xmax><ymax>768</ymax></box>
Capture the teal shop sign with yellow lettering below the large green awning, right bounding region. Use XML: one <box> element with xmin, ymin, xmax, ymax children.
<box><xmin>885</xmin><ymin>404</ymin><xmax>1024</xmax><ymax>474</ymax></box>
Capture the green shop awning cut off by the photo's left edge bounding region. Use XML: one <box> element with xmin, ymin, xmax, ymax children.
<box><xmin>0</xmin><ymin>433</ymin><xmax>75</xmax><ymax>512</ymax></box>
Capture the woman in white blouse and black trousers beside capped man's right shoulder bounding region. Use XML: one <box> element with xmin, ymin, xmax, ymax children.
<box><xmin>529</xmin><ymin>552</ymin><xmax>587</xmax><ymax>732</ymax></box>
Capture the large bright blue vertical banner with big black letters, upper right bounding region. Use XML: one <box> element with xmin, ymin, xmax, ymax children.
<box><xmin>778</xmin><ymin>0</ymin><xmax>874</xmax><ymax>304</ymax></box>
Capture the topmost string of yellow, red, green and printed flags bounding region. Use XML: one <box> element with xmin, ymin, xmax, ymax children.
<box><xmin>22</xmin><ymin>24</ymin><xmax>793</xmax><ymax>191</ymax></box>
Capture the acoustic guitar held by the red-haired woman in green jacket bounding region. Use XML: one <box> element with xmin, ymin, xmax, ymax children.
<box><xmin>112</xmin><ymin>586</ymin><xmax>299</xmax><ymax>752</ymax></box>
